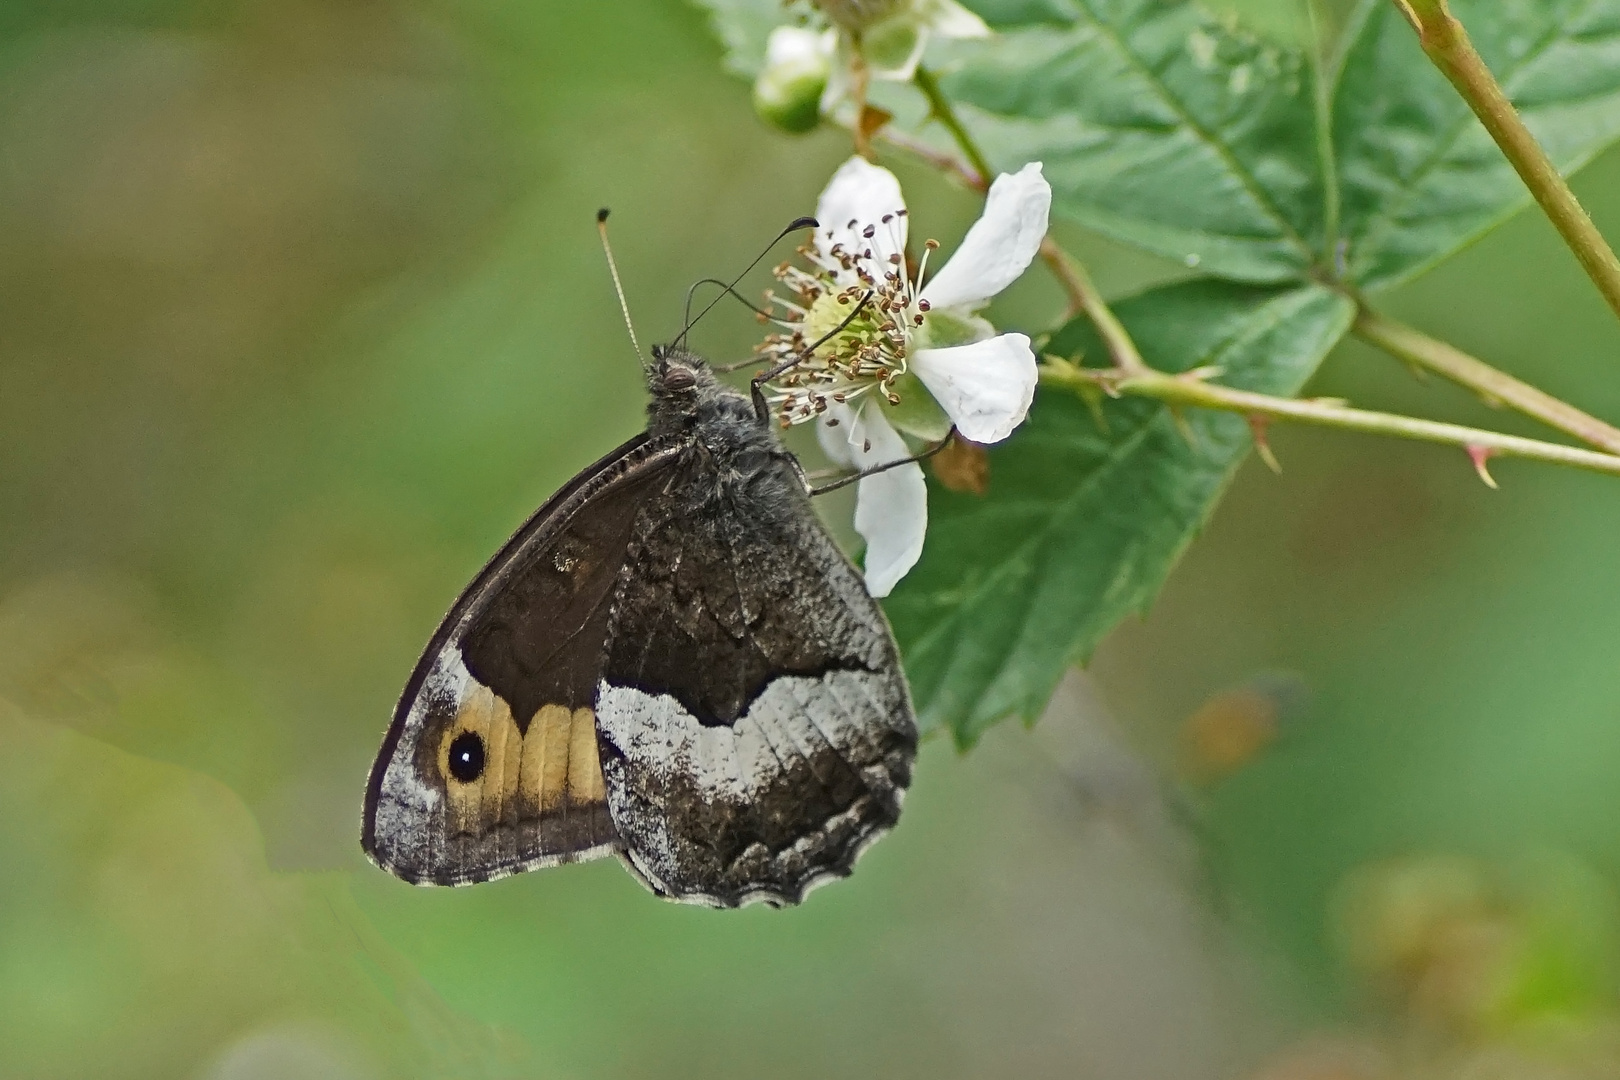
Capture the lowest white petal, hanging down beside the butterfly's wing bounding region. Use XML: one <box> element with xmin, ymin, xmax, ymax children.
<box><xmin>849</xmin><ymin>402</ymin><xmax>928</xmax><ymax>596</ymax></box>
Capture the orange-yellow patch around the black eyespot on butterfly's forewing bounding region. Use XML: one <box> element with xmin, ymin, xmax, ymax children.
<box><xmin>437</xmin><ymin>683</ymin><xmax>606</xmax><ymax>836</ymax></box>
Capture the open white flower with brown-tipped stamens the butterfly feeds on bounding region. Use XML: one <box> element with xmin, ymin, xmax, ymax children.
<box><xmin>761</xmin><ymin>157</ymin><xmax>1051</xmax><ymax>596</ymax></box>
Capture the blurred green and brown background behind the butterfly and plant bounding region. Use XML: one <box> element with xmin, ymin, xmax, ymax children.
<box><xmin>9</xmin><ymin>0</ymin><xmax>1620</xmax><ymax>1080</ymax></box>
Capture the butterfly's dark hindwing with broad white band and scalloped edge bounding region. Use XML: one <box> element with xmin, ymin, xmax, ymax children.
<box><xmin>596</xmin><ymin>453</ymin><xmax>917</xmax><ymax>907</ymax></box>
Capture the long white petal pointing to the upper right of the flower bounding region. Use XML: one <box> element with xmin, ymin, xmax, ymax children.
<box><xmin>922</xmin><ymin>162</ymin><xmax>1051</xmax><ymax>312</ymax></box>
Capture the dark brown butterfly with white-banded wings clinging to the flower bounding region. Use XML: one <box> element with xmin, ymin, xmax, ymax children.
<box><xmin>361</xmin><ymin>222</ymin><xmax>917</xmax><ymax>907</ymax></box>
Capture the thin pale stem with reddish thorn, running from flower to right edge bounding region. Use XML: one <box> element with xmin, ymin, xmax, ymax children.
<box><xmin>1040</xmin><ymin>361</ymin><xmax>1620</xmax><ymax>476</ymax></box>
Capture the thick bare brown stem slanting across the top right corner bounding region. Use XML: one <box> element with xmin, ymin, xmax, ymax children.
<box><xmin>1395</xmin><ymin>0</ymin><xmax>1620</xmax><ymax>325</ymax></box>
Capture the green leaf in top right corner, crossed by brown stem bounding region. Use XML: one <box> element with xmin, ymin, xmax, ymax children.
<box><xmin>1333</xmin><ymin>0</ymin><xmax>1620</xmax><ymax>290</ymax></box>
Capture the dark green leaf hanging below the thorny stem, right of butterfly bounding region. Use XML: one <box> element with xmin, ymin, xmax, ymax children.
<box><xmin>885</xmin><ymin>280</ymin><xmax>1353</xmax><ymax>745</ymax></box>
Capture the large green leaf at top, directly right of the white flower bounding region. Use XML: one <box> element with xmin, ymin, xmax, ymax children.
<box><xmin>944</xmin><ymin>0</ymin><xmax>1324</xmax><ymax>282</ymax></box>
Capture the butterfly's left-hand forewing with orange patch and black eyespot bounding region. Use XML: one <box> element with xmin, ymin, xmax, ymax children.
<box><xmin>361</xmin><ymin>436</ymin><xmax>676</xmax><ymax>884</ymax></box>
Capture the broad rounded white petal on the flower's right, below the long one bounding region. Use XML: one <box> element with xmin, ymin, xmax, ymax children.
<box><xmin>910</xmin><ymin>334</ymin><xmax>1038</xmax><ymax>442</ymax></box>
